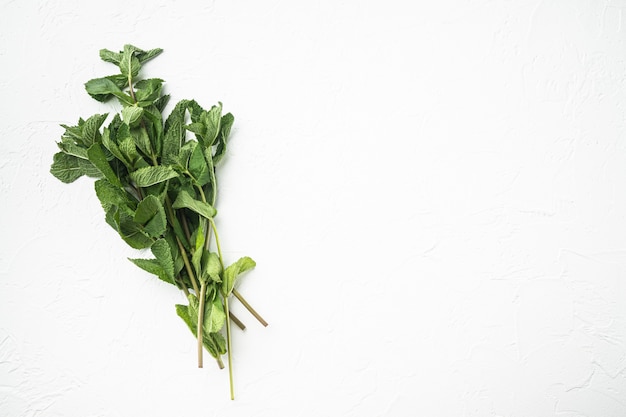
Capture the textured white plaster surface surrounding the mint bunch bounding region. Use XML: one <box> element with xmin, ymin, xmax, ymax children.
<box><xmin>0</xmin><ymin>0</ymin><xmax>626</xmax><ymax>417</ymax></box>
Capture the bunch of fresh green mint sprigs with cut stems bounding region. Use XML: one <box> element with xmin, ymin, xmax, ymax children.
<box><xmin>50</xmin><ymin>45</ymin><xmax>267</xmax><ymax>399</ymax></box>
